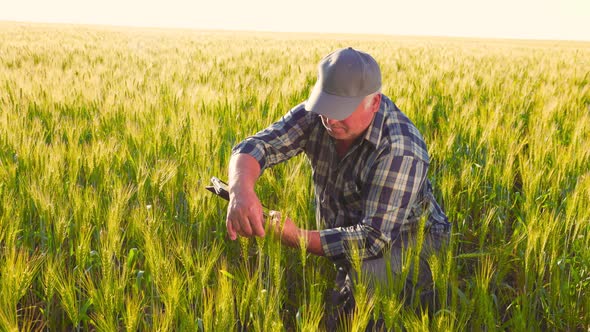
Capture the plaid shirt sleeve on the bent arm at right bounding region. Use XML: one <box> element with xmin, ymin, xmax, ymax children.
<box><xmin>320</xmin><ymin>154</ymin><xmax>428</xmax><ymax>260</ymax></box>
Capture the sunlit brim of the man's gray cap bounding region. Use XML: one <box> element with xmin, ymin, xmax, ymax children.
<box><xmin>305</xmin><ymin>83</ymin><xmax>364</xmax><ymax>121</ymax></box>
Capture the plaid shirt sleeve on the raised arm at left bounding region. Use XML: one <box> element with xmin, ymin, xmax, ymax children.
<box><xmin>232</xmin><ymin>103</ymin><xmax>313</xmax><ymax>171</ymax></box>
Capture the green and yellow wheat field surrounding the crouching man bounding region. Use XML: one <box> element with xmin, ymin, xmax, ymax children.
<box><xmin>0</xmin><ymin>23</ymin><xmax>590</xmax><ymax>331</ymax></box>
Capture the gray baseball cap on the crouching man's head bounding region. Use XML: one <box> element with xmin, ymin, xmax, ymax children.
<box><xmin>305</xmin><ymin>47</ymin><xmax>381</xmax><ymax>121</ymax></box>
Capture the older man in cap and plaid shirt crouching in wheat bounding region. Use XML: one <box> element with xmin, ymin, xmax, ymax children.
<box><xmin>226</xmin><ymin>47</ymin><xmax>450</xmax><ymax>326</ymax></box>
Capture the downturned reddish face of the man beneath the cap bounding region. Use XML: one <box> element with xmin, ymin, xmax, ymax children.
<box><xmin>321</xmin><ymin>95</ymin><xmax>381</xmax><ymax>141</ymax></box>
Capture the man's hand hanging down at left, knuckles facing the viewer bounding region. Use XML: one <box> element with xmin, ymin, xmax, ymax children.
<box><xmin>226</xmin><ymin>189</ymin><xmax>264</xmax><ymax>240</ymax></box>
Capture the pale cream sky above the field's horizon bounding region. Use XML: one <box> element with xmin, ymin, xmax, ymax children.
<box><xmin>0</xmin><ymin>0</ymin><xmax>590</xmax><ymax>41</ymax></box>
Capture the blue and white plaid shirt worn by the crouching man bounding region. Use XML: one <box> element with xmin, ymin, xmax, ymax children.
<box><xmin>233</xmin><ymin>96</ymin><xmax>450</xmax><ymax>261</ymax></box>
